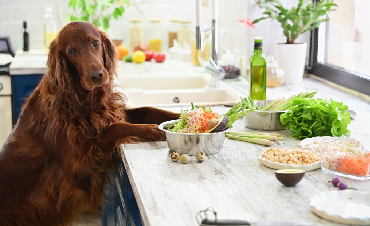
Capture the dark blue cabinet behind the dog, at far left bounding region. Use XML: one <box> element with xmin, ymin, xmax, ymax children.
<box><xmin>11</xmin><ymin>74</ymin><xmax>44</xmax><ymax>125</ymax></box>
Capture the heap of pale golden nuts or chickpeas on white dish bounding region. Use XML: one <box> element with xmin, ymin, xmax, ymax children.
<box><xmin>260</xmin><ymin>148</ymin><xmax>321</xmax><ymax>165</ymax></box>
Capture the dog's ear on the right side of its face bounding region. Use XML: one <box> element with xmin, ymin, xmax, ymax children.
<box><xmin>99</xmin><ymin>30</ymin><xmax>117</xmax><ymax>76</ymax></box>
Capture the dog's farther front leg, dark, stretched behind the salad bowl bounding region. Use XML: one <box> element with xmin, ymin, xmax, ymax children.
<box><xmin>124</xmin><ymin>107</ymin><xmax>180</xmax><ymax>124</ymax></box>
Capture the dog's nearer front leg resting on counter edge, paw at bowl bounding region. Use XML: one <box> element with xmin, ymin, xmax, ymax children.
<box><xmin>97</xmin><ymin>122</ymin><xmax>166</xmax><ymax>151</ymax></box>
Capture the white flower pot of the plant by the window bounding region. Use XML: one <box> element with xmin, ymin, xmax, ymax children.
<box><xmin>275</xmin><ymin>43</ymin><xmax>307</xmax><ymax>83</ymax></box>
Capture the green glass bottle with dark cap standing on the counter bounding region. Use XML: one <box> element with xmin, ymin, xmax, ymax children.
<box><xmin>249</xmin><ymin>37</ymin><xmax>266</xmax><ymax>100</ymax></box>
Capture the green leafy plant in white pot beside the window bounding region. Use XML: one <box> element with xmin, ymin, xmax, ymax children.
<box><xmin>253</xmin><ymin>0</ymin><xmax>337</xmax><ymax>83</ymax></box>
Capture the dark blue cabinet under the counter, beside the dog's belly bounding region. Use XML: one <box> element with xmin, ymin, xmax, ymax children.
<box><xmin>101</xmin><ymin>161</ymin><xmax>142</xmax><ymax>226</ymax></box>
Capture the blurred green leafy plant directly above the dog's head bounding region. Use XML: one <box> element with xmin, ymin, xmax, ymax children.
<box><xmin>68</xmin><ymin>0</ymin><xmax>132</xmax><ymax>30</ymax></box>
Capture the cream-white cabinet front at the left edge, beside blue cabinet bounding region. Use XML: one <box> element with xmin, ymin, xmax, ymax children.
<box><xmin>0</xmin><ymin>96</ymin><xmax>13</xmax><ymax>149</ymax></box>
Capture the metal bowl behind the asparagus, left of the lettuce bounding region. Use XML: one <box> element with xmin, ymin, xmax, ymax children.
<box><xmin>243</xmin><ymin>100</ymin><xmax>287</xmax><ymax>130</ymax></box>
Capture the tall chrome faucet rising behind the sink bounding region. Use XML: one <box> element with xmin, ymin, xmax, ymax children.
<box><xmin>195</xmin><ymin>0</ymin><xmax>225</xmax><ymax>89</ymax></box>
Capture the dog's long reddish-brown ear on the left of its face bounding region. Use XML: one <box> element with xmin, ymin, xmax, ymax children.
<box><xmin>46</xmin><ymin>39</ymin><xmax>71</xmax><ymax>93</ymax></box>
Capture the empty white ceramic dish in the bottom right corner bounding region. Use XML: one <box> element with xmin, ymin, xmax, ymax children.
<box><xmin>310</xmin><ymin>190</ymin><xmax>370</xmax><ymax>225</ymax></box>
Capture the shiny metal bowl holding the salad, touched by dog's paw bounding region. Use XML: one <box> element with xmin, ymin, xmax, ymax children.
<box><xmin>158</xmin><ymin>120</ymin><xmax>226</xmax><ymax>156</ymax></box>
